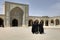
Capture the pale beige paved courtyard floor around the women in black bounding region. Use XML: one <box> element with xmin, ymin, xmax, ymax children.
<box><xmin>0</xmin><ymin>27</ymin><xmax>60</xmax><ymax>40</ymax></box>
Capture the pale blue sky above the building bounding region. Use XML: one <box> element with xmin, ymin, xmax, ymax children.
<box><xmin>0</xmin><ymin>0</ymin><xmax>60</xmax><ymax>16</ymax></box>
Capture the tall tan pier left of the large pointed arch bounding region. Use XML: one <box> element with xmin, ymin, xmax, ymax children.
<box><xmin>5</xmin><ymin>4</ymin><xmax>10</xmax><ymax>27</ymax></box>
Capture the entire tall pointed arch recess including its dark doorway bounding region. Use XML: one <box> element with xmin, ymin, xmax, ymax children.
<box><xmin>10</xmin><ymin>7</ymin><xmax>24</xmax><ymax>26</ymax></box>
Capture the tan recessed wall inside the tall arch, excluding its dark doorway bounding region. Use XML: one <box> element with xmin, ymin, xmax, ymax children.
<box><xmin>10</xmin><ymin>7</ymin><xmax>24</xmax><ymax>26</ymax></box>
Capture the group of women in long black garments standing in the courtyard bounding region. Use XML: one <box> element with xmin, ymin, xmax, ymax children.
<box><xmin>32</xmin><ymin>20</ymin><xmax>44</xmax><ymax>34</ymax></box>
